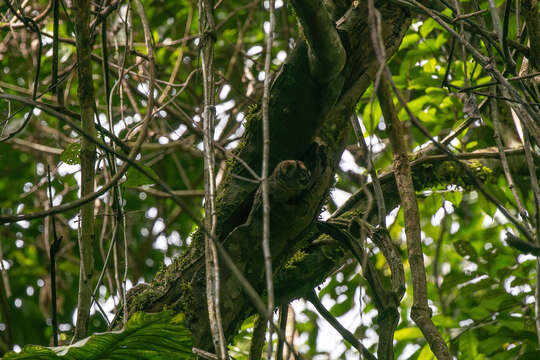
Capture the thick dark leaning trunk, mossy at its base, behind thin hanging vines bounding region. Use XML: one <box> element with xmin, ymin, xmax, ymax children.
<box><xmin>127</xmin><ymin>4</ymin><xmax>409</xmax><ymax>349</ymax></box>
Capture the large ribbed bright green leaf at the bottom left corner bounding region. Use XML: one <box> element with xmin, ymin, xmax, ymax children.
<box><xmin>4</xmin><ymin>311</ymin><xmax>195</xmax><ymax>360</ymax></box>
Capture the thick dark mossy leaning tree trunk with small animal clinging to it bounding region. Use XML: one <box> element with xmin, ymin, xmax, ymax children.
<box><xmin>129</xmin><ymin>1</ymin><xmax>410</xmax><ymax>350</ymax></box>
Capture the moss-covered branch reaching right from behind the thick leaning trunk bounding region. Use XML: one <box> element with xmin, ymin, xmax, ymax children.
<box><xmin>276</xmin><ymin>149</ymin><xmax>538</xmax><ymax>302</ymax></box>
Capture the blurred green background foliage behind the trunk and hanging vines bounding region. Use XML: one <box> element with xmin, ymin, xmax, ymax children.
<box><xmin>0</xmin><ymin>0</ymin><xmax>540</xmax><ymax>359</ymax></box>
